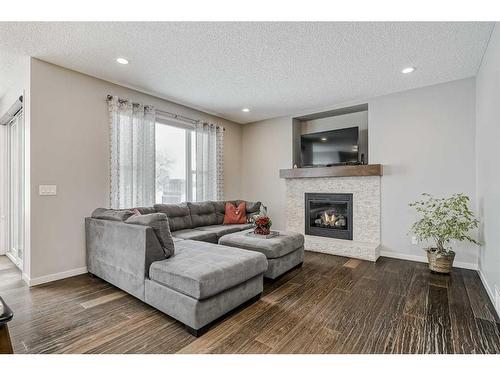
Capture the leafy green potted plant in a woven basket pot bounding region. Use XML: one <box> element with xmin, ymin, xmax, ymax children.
<box><xmin>410</xmin><ymin>193</ymin><xmax>479</xmax><ymax>273</ymax></box>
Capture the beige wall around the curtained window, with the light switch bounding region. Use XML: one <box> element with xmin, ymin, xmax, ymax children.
<box><xmin>29</xmin><ymin>59</ymin><xmax>241</xmax><ymax>282</ymax></box>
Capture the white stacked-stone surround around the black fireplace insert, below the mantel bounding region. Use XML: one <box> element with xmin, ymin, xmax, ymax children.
<box><xmin>285</xmin><ymin>176</ymin><xmax>380</xmax><ymax>261</ymax></box>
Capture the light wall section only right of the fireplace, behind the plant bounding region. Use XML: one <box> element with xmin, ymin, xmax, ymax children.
<box><xmin>368</xmin><ymin>78</ymin><xmax>477</xmax><ymax>265</ymax></box>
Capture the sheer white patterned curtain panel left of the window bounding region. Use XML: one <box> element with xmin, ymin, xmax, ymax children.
<box><xmin>108</xmin><ymin>96</ymin><xmax>155</xmax><ymax>208</ymax></box>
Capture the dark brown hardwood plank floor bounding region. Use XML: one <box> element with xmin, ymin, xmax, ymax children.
<box><xmin>0</xmin><ymin>252</ymin><xmax>500</xmax><ymax>353</ymax></box>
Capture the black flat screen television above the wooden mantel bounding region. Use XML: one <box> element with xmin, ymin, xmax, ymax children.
<box><xmin>300</xmin><ymin>126</ymin><xmax>359</xmax><ymax>167</ymax></box>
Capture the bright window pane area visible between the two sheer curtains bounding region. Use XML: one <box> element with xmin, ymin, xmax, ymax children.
<box><xmin>155</xmin><ymin>120</ymin><xmax>196</xmax><ymax>203</ymax></box>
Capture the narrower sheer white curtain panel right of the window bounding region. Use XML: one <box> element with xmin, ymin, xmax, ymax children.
<box><xmin>195</xmin><ymin>121</ymin><xmax>224</xmax><ymax>202</ymax></box>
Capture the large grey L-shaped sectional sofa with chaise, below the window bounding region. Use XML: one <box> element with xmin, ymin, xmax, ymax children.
<box><xmin>85</xmin><ymin>201</ymin><xmax>268</xmax><ymax>336</ymax></box>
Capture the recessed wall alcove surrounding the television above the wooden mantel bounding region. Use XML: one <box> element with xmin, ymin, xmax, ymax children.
<box><xmin>292</xmin><ymin>104</ymin><xmax>369</xmax><ymax>168</ymax></box>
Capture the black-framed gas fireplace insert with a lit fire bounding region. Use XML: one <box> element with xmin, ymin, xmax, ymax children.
<box><xmin>305</xmin><ymin>193</ymin><xmax>352</xmax><ymax>240</ymax></box>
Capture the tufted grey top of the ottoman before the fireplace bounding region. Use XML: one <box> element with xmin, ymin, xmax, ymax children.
<box><xmin>219</xmin><ymin>231</ymin><xmax>304</xmax><ymax>259</ymax></box>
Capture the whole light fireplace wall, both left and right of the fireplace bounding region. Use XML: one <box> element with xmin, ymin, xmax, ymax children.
<box><xmin>242</xmin><ymin>78</ymin><xmax>477</xmax><ymax>267</ymax></box>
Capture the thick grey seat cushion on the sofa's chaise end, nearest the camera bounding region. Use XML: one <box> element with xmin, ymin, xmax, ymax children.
<box><xmin>149</xmin><ymin>241</ymin><xmax>267</xmax><ymax>300</ymax></box>
